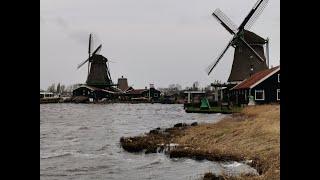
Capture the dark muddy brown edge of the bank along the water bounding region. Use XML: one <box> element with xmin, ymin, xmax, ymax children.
<box><xmin>120</xmin><ymin>122</ymin><xmax>262</xmax><ymax>179</ymax></box>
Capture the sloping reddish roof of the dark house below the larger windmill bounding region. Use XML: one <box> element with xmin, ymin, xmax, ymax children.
<box><xmin>230</xmin><ymin>66</ymin><xmax>280</xmax><ymax>90</ymax></box>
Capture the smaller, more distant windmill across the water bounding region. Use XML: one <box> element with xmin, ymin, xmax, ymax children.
<box><xmin>77</xmin><ymin>34</ymin><xmax>115</xmax><ymax>88</ymax></box>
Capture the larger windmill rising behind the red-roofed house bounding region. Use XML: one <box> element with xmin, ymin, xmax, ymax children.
<box><xmin>207</xmin><ymin>0</ymin><xmax>269</xmax><ymax>82</ymax></box>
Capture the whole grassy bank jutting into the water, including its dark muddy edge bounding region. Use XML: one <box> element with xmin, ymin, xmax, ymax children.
<box><xmin>120</xmin><ymin>105</ymin><xmax>280</xmax><ymax>179</ymax></box>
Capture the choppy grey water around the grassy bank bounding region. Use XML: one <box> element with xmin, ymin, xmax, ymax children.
<box><xmin>40</xmin><ymin>104</ymin><xmax>253</xmax><ymax>180</ymax></box>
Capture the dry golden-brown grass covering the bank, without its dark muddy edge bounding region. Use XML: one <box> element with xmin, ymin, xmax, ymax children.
<box><xmin>174</xmin><ymin>105</ymin><xmax>280</xmax><ymax>179</ymax></box>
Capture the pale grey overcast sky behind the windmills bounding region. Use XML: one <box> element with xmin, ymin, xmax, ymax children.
<box><xmin>40</xmin><ymin>0</ymin><xmax>280</xmax><ymax>89</ymax></box>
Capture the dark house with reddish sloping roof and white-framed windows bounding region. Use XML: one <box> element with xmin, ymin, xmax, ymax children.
<box><xmin>228</xmin><ymin>66</ymin><xmax>280</xmax><ymax>105</ymax></box>
